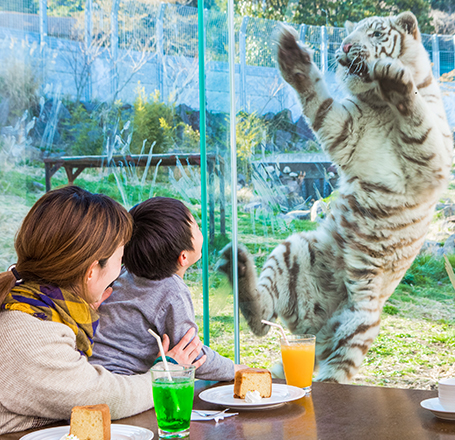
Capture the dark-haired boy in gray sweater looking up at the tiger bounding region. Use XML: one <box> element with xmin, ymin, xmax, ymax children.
<box><xmin>90</xmin><ymin>197</ymin><xmax>243</xmax><ymax>381</ymax></box>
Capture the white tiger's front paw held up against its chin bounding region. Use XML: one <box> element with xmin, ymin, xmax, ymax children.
<box><xmin>372</xmin><ymin>58</ymin><xmax>415</xmax><ymax>115</ymax></box>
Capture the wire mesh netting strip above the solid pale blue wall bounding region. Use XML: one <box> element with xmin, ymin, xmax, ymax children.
<box><xmin>0</xmin><ymin>0</ymin><xmax>455</xmax><ymax>78</ymax></box>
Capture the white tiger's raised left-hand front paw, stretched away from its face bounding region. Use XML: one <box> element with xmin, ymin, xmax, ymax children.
<box><xmin>277</xmin><ymin>25</ymin><xmax>318</xmax><ymax>93</ymax></box>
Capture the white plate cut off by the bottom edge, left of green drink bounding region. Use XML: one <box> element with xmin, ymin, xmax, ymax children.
<box><xmin>20</xmin><ymin>424</ymin><xmax>153</xmax><ymax>440</ymax></box>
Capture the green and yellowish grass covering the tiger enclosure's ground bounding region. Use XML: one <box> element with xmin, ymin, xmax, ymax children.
<box><xmin>0</xmin><ymin>165</ymin><xmax>455</xmax><ymax>389</ymax></box>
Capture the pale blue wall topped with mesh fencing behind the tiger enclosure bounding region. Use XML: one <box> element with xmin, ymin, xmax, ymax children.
<box><xmin>0</xmin><ymin>0</ymin><xmax>455</xmax><ymax>116</ymax></box>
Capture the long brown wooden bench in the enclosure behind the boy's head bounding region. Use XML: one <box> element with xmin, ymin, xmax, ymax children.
<box><xmin>43</xmin><ymin>153</ymin><xmax>226</xmax><ymax>243</ymax></box>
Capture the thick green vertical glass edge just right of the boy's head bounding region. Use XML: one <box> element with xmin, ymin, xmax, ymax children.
<box><xmin>197</xmin><ymin>0</ymin><xmax>210</xmax><ymax>346</ymax></box>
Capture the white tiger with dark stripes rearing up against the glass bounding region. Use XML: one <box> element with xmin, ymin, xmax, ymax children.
<box><xmin>219</xmin><ymin>12</ymin><xmax>453</xmax><ymax>382</ymax></box>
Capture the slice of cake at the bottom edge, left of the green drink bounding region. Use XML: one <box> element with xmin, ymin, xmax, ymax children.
<box><xmin>70</xmin><ymin>404</ymin><xmax>111</xmax><ymax>440</ymax></box>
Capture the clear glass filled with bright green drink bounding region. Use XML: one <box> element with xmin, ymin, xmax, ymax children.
<box><xmin>150</xmin><ymin>365</ymin><xmax>195</xmax><ymax>438</ymax></box>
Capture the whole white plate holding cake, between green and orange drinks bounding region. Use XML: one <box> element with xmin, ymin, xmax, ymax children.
<box><xmin>199</xmin><ymin>383</ymin><xmax>305</xmax><ymax>409</ymax></box>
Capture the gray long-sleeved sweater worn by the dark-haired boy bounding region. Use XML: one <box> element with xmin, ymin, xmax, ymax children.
<box><xmin>89</xmin><ymin>269</ymin><xmax>234</xmax><ymax>381</ymax></box>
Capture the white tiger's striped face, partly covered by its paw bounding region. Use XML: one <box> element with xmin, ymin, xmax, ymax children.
<box><xmin>335</xmin><ymin>12</ymin><xmax>423</xmax><ymax>94</ymax></box>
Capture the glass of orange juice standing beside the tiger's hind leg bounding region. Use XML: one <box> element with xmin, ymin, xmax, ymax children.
<box><xmin>281</xmin><ymin>335</ymin><xmax>316</xmax><ymax>392</ymax></box>
